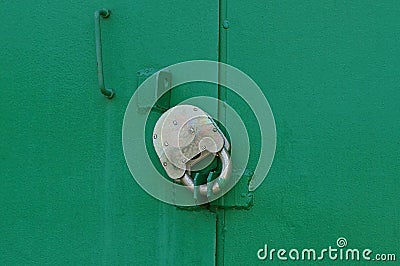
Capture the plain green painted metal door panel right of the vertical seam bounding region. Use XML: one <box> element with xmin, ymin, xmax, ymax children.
<box><xmin>225</xmin><ymin>0</ymin><xmax>400</xmax><ymax>265</ymax></box>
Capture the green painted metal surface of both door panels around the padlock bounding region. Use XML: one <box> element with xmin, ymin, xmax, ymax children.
<box><xmin>0</xmin><ymin>0</ymin><xmax>400</xmax><ymax>265</ymax></box>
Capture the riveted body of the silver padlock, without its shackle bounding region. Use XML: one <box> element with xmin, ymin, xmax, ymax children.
<box><xmin>153</xmin><ymin>105</ymin><xmax>228</xmax><ymax>179</ymax></box>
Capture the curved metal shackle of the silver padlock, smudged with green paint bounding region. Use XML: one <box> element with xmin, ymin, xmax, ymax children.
<box><xmin>180</xmin><ymin>148</ymin><xmax>232</xmax><ymax>196</ymax></box>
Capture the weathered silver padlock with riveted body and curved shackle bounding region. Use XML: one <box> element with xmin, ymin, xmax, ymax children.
<box><xmin>153</xmin><ymin>105</ymin><xmax>232</xmax><ymax>195</ymax></box>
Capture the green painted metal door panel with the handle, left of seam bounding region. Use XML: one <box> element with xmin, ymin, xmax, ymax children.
<box><xmin>0</xmin><ymin>0</ymin><xmax>218</xmax><ymax>265</ymax></box>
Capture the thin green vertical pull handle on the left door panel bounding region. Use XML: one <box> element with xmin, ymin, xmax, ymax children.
<box><xmin>94</xmin><ymin>8</ymin><xmax>114</xmax><ymax>99</ymax></box>
